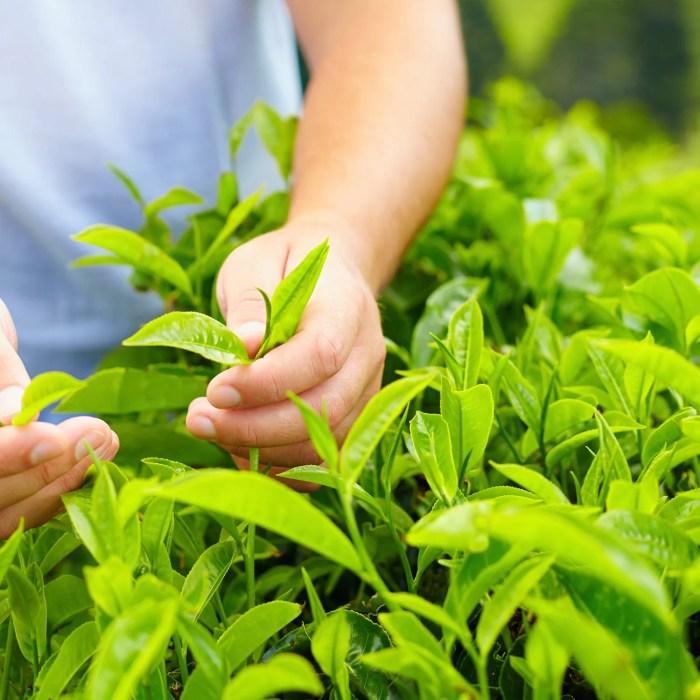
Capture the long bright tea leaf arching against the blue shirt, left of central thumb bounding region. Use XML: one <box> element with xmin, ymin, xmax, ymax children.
<box><xmin>73</xmin><ymin>224</ymin><xmax>192</xmax><ymax>297</ymax></box>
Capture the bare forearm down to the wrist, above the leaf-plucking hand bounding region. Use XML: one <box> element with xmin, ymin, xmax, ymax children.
<box><xmin>282</xmin><ymin>0</ymin><xmax>466</xmax><ymax>292</ymax></box>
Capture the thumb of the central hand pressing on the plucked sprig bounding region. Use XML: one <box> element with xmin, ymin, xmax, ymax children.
<box><xmin>216</xmin><ymin>246</ymin><xmax>281</xmax><ymax>357</ymax></box>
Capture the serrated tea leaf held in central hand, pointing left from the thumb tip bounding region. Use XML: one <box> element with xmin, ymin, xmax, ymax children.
<box><xmin>122</xmin><ymin>311</ymin><xmax>250</xmax><ymax>365</ymax></box>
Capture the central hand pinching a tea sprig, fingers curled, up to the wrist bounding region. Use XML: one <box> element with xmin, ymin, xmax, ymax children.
<box><xmin>187</xmin><ymin>222</ymin><xmax>385</xmax><ymax>473</ymax></box>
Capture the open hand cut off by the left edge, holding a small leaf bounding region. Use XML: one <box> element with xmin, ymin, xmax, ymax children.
<box><xmin>0</xmin><ymin>300</ymin><xmax>119</xmax><ymax>539</ymax></box>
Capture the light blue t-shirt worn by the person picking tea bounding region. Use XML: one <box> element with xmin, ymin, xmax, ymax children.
<box><xmin>0</xmin><ymin>0</ymin><xmax>301</xmax><ymax>376</ymax></box>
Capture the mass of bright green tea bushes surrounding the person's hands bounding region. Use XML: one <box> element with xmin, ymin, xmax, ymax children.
<box><xmin>0</xmin><ymin>81</ymin><xmax>700</xmax><ymax>700</ymax></box>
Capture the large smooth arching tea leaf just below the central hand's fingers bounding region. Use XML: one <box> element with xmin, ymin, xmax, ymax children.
<box><xmin>153</xmin><ymin>469</ymin><xmax>362</xmax><ymax>573</ymax></box>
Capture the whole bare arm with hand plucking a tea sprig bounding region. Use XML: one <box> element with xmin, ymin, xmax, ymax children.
<box><xmin>187</xmin><ymin>0</ymin><xmax>466</xmax><ymax>466</ymax></box>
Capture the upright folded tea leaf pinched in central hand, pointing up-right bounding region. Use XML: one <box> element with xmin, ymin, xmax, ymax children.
<box><xmin>256</xmin><ymin>240</ymin><xmax>329</xmax><ymax>357</ymax></box>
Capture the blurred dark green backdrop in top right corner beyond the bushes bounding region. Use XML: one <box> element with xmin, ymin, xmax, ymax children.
<box><xmin>460</xmin><ymin>0</ymin><xmax>700</xmax><ymax>138</ymax></box>
